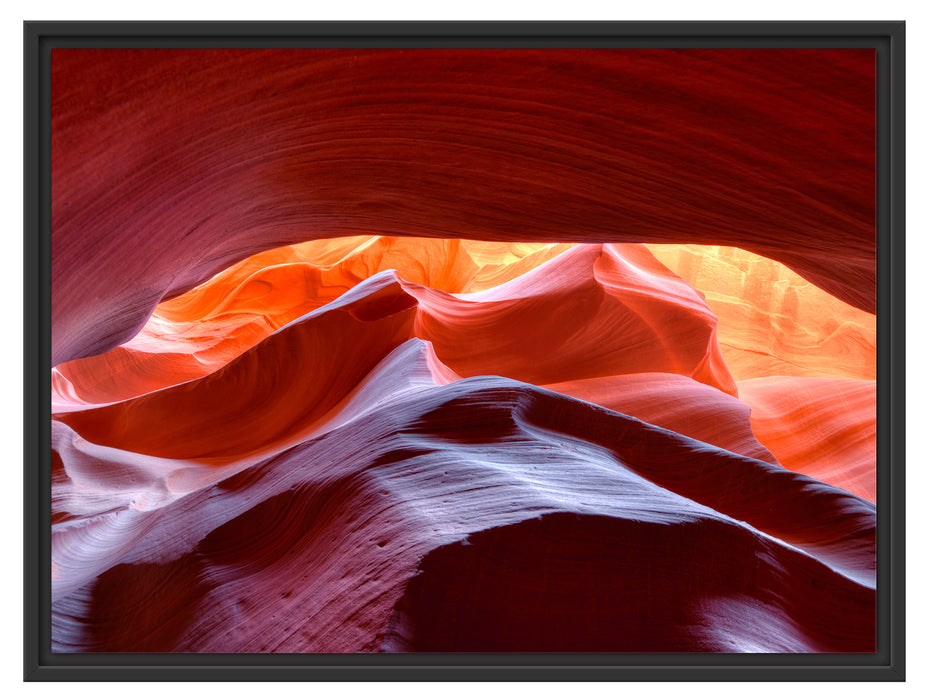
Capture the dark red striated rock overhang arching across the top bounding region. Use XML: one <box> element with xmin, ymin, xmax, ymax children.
<box><xmin>51</xmin><ymin>49</ymin><xmax>875</xmax><ymax>365</ymax></box>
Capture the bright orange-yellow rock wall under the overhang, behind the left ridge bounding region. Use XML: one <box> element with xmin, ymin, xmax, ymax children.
<box><xmin>52</xmin><ymin>236</ymin><xmax>572</xmax><ymax>413</ymax></box>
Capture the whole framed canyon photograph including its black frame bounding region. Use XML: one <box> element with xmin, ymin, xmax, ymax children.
<box><xmin>24</xmin><ymin>22</ymin><xmax>905</xmax><ymax>681</ymax></box>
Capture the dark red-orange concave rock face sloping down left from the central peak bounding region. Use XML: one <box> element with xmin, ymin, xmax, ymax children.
<box><xmin>59</xmin><ymin>273</ymin><xmax>417</xmax><ymax>461</ymax></box>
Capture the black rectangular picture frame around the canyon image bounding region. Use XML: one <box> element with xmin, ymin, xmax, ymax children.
<box><xmin>24</xmin><ymin>22</ymin><xmax>905</xmax><ymax>681</ymax></box>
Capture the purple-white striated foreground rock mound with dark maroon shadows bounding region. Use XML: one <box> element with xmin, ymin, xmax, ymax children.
<box><xmin>53</xmin><ymin>340</ymin><xmax>875</xmax><ymax>652</ymax></box>
